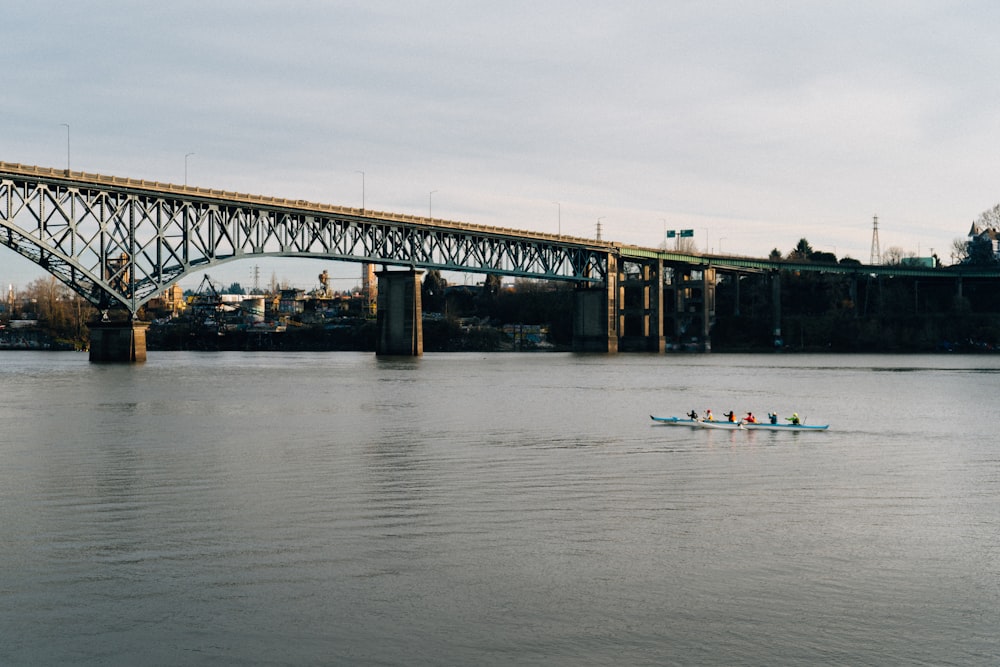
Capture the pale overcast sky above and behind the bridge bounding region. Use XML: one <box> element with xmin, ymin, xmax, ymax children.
<box><xmin>0</xmin><ymin>0</ymin><xmax>1000</xmax><ymax>289</ymax></box>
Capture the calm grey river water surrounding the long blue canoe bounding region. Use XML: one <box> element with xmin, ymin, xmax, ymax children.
<box><xmin>0</xmin><ymin>352</ymin><xmax>1000</xmax><ymax>665</ymax></box>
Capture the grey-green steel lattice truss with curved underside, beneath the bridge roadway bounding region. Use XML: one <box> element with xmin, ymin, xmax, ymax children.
<box><xmin>0</xmin><ymin>163</ymin><xmax>613</xmax><ymax>315</ymax></box>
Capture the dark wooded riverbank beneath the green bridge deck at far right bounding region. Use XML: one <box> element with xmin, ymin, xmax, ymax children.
<box><xmin>712</xmin><ymin>271</ymin><xmax>1000</xmax><ymax>352</ymax></box>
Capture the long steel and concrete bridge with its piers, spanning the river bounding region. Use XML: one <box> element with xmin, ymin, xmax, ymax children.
<box><xmin>0</xmin><ymin>162</ymin><xmax>1000</xmax><ymax>361</ymax></box>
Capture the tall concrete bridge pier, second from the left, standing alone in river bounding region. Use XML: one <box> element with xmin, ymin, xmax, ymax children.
<box><xmin>375</xmin><ymin>269</ymin><xmax>424</xmax><ymax>357</ymax></box>
